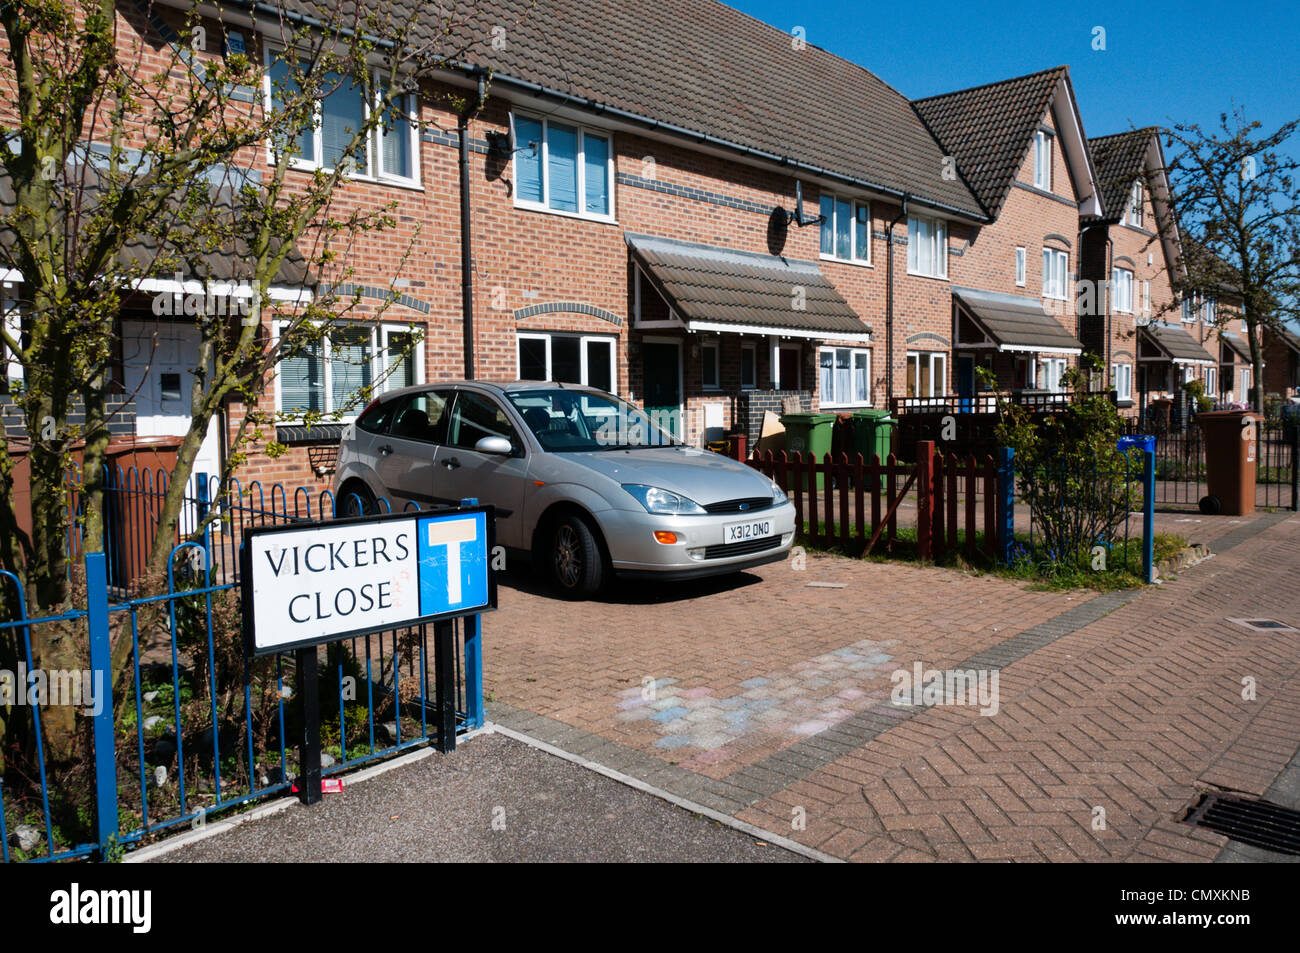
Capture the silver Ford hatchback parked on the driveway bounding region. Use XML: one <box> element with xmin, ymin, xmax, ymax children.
<box><xmin>334</xmin><ymin>381</ymin><xmax>794</xmax><ymax>598</ymax></box>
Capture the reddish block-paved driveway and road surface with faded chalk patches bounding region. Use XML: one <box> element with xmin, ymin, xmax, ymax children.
<box><xmin>484</xmin><ymin>514</ymin><xmax>1300</xmax><ymax>861</ymax></box>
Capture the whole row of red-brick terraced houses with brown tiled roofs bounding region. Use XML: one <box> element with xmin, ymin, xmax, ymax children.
<box><xmin>4</xmin><ymin>0</ymin><xmax>1279</xmax><ymax>484</ymax></box>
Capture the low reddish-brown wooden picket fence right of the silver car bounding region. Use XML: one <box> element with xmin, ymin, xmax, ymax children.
<box><xmin>748</xmin><ymin>441</ymin><xmax>1000</xmax><ymax>560</ymax></box>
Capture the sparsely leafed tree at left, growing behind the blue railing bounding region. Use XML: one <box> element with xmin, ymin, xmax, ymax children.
<box><xmin>0</xmin><ymin>0</ymin><xmax>506</xmax><ymax>764</ymax></box>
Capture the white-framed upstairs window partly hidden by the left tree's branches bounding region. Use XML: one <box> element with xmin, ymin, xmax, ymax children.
<box><xmin>265</xmin><ymin>53</ymin><xmax>419</xmax><ymax>183</ymax></box>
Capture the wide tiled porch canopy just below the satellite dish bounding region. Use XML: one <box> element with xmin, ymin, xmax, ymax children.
<box><xmin>625</xmin><ymin>233</ymin><xmax>871</xmax><ymax>341</ymax></box>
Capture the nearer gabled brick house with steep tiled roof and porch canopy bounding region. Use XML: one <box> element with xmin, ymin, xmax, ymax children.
<box><xmin>915</xmin><ymin>66</ymin><xmax>1102</xmax><ymax>408</ymax></box>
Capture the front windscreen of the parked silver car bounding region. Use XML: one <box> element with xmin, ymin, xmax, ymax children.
<box><xmin>508</xmin><ymin>387</ymin><xmax>683</xmax><ymax>452</ymax></box>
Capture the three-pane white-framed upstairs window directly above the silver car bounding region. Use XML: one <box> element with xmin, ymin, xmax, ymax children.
<box><xmin>514</xmin><ymin>116</ymin><xmax>614</xmax><ymax>220</ymax></box>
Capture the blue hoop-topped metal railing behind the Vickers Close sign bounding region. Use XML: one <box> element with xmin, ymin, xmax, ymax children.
<box><xmin>0</xmin><ymin>469</ymin><xmax>484</xmax><ymax>862</ymax></box>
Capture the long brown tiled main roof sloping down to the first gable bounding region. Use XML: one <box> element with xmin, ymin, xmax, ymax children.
<box><xmin>290</xmin><ymin>0</ymin><xmax>983</xmax><ymax>218</ymax></box>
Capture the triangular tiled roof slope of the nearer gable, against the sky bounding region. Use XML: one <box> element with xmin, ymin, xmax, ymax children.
<box><xmin>913</xmin><ymin>66</ymin><xmax>1069</xmax><ymax>217</ymax></box>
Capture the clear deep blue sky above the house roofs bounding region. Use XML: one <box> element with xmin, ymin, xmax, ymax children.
<box><xmin>727</xmin><ymin>0</ymin><xmax>1300</xmax><ymax>153</ymax></box>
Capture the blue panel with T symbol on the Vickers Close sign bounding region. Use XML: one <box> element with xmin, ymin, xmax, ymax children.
<box><xmin>417</xmin><ymin>512</ymin><xmax>488</xmax><ymax>615</ymax></box>
